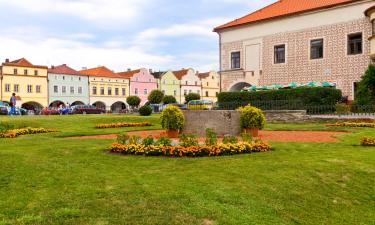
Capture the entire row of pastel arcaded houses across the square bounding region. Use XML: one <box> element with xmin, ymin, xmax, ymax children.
<box><xmin>0</xmin><ymin>58</ymin><xmax>220</xmax><ymax>111</ymax></box>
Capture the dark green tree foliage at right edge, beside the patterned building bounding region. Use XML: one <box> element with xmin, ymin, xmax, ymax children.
<box><xmin>354</xmin><ymin>64</ymin><xmax>375</xmax><ymax>106</ymax></box>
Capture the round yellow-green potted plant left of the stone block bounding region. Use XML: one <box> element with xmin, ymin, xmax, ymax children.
<box><xmin>160</xmin><ymin>105</ymin><xmax>185</xmax><ymax>138</ymax></box>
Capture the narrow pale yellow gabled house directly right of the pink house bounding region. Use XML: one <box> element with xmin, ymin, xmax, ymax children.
<box><xmin>158</xmin><ymin>71</ymin><xmax>182</xmax><ymax>103</ymax></box>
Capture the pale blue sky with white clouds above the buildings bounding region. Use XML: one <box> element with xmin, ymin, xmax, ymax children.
<box><xmin>0</xmin><ymin>0</ymin><xmax>275</xmax><ymax>72</ymax></box>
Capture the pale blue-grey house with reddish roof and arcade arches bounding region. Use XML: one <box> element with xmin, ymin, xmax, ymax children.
<box><xmin>48</xmin><ymin>64</ymin><xmax>90</xmax><ymax>107</ymax></box>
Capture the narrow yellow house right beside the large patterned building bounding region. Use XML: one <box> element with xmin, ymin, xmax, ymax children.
<box><xmin>198</xmin><ymin>71</ymin><xmax>220</xmax><ymax>102</ymax></box>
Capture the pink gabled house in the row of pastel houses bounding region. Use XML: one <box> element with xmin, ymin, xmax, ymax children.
<box><xmin>118</xmin><ymin>68</ymin><xmax>157</xmax><ymax>105</ymax></box>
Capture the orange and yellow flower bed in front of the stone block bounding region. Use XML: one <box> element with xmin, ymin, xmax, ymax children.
<box><xmin>109</xmin><ymin>141</ymin><xmax>271</xmax><ymax>157</ymax></box>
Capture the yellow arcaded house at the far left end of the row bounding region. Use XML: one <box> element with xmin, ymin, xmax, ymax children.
<box><xmin>0</xmin><ymin>58</ymin><xmax>48</xmax><ymax>111</ymax></box>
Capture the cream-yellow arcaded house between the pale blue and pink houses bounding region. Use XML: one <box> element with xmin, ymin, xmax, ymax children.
<box><xmin>79</xmin><ymin>66</ymin><xmax>129</xmax><ymax>112</ymax></box>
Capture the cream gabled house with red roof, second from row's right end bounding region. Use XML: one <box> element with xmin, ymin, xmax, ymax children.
<box><xmin>173</xmin><ymin>69</ymin><xmax>202</xmax><ymax>103</ymax></box>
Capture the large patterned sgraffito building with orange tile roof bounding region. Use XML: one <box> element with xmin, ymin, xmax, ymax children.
<box><xmin>215</xmin><ymin>0</ymin><xmax>375</xmax><ymax>100</ymax></box>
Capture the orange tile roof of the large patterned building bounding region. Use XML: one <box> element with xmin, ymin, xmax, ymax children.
<box><xmin>214</xmin><ymin>0</ymin><xmax>360</xmax><ymax>32</ymax></box>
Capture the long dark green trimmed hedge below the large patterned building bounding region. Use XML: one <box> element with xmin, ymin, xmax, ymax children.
<box><xmin>218</xmin><ymin>87</ymin><xmax>342</xmax><ymax>109</ymax></box>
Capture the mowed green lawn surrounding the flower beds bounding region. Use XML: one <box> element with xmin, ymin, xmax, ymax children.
<box><xmin>0</xmin><ymin>115</ymin><xmax>375</xmax><ymax>225</ymax></box>
